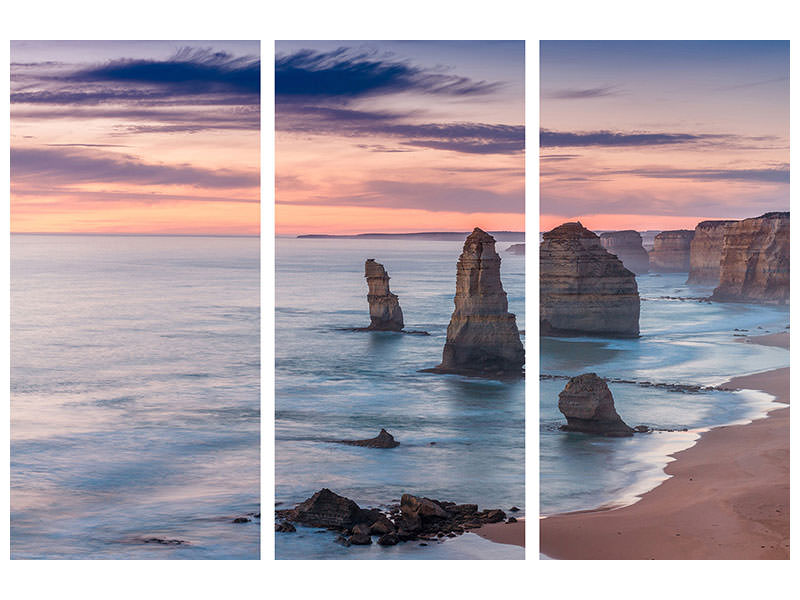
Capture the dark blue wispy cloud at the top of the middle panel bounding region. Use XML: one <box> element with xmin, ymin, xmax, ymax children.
<box><xmin>275</xmin><ymin>47</ymin><xmax>501</xmax><ymax>101</ymax></box>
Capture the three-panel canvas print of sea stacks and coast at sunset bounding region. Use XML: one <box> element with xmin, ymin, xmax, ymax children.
<box><xmin>9</xmin><ymin>40</ymin><xmax>790</xmax><ymax>560</ymax></box>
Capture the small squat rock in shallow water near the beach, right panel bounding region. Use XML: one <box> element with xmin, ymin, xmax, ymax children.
<box><xmin>558</xmin><ymin>373</ymin><xmax>633</xmax><ymax>437</ymax></box>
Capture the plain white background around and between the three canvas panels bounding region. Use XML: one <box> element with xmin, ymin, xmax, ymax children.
<box><xmin>0</xmin><ymin>0</ymin><xmax>800</xmax><ymax>600</ymax></box>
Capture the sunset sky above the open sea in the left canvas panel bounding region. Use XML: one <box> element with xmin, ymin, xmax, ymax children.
<box><xmin>11</xmin><ymin>41</ymin><xmax>260</xmax><ymax>235</ymax></box>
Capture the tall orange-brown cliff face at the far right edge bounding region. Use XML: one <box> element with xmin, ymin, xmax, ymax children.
<box><xmin>711</xmin><ymin>212</ymin><xmax>789</xmax><ymax>304</ymax></box>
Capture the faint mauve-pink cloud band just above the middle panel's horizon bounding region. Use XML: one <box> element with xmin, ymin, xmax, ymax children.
<box><xmin>278</xmin><ymin>180</ymin><xmax>525</xmax><ymax>214</ymax></box>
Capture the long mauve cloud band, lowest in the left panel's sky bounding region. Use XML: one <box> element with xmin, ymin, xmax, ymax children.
<box><xmin>11</xmin><ymin>147</ymin><xmax>259</xmax><ymax>189</ymax></box>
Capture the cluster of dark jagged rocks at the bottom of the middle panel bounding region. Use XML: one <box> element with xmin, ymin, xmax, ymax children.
<box><xmin>275</xmin><ymin>488</ymin><xmax>519</xmax><ymax>546</ymax></box>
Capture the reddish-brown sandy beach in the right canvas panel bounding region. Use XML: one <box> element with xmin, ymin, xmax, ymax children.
<box><xmin>540</xmin><ymin>333</ymin><xmax>789</xmax><ymax>559</ymax></box>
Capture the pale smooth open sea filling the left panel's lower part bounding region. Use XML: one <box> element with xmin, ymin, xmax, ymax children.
<box><xmin>10</xmin><ymin>235</ymin><xmax>260</xmax><ymax>559</ymax></box>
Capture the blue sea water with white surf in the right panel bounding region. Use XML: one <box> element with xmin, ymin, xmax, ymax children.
<box><xmin>539</xmin><ymin>273</ymin><xmax>789</xmax><ymax>515</ymax></box>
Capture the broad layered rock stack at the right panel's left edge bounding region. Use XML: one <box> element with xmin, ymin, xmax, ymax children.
<box><xmin>539</xmin><ymin>223</ymin><xmax>639</xmax><ymax>337</ymax></box>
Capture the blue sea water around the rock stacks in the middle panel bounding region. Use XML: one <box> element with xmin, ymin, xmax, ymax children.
<box><xmin>275</xmin><ymin>237</ymin><xmax>525</xmax><ymax>559</ymax></box>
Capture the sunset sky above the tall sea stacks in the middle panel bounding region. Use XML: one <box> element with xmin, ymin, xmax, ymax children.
<box><xmin>275</xmin><ymin>41</ymin><xmax>525</xmax><ymax>234</ymax></box>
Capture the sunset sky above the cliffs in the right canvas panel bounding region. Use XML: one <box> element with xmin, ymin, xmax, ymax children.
<box><xmin>540</xmin><ymin>41</ymin><xmax>789</xmax><ymax>231</ymax></box>
